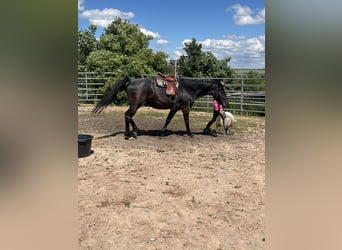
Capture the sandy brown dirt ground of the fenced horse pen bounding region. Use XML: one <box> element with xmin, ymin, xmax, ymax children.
<box><xmin>78</xmin><ymin>105</ymin><xmax>266</xmax><ymax>250</ymax></box>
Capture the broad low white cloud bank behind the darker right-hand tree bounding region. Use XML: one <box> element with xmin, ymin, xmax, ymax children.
<box><xmin>172</xmin><ymin>36</ymin><xmax>265</xmax><ymax>69</ymax></box>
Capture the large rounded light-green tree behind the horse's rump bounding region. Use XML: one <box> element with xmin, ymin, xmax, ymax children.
<box><xmin>85</xmin><ymin>18</ymin><xmax>168</xmax><ymax>104</ymax></box>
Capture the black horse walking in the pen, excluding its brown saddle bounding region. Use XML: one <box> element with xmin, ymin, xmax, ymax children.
<box><xmin>92</xmin><ymin>78</ymin><xmax>228</xmax><ymax>139</ymax></box>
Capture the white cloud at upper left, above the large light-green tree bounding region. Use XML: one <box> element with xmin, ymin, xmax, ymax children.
<box><xmin>79</xmin><ymin>8</ymin><xmax>134</xmax><ymax>28</ymax></box>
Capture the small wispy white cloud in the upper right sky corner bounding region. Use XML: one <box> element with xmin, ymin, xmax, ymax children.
<box><xmin>227</xmin><ymin>4</ymin><xmax>265</xmax><ymax>25</ymax></box>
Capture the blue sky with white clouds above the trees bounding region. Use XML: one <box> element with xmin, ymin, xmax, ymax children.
<box><xmin>78</xmin><ymin>0</ymin><xmax>265</xmax><ymax>69</ymax></box>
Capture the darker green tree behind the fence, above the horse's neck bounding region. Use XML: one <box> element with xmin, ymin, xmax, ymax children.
<box><xmin>177</xmin><ymin>38</ymin><xmax>233</xmax><ymax>78</ymax></box>
